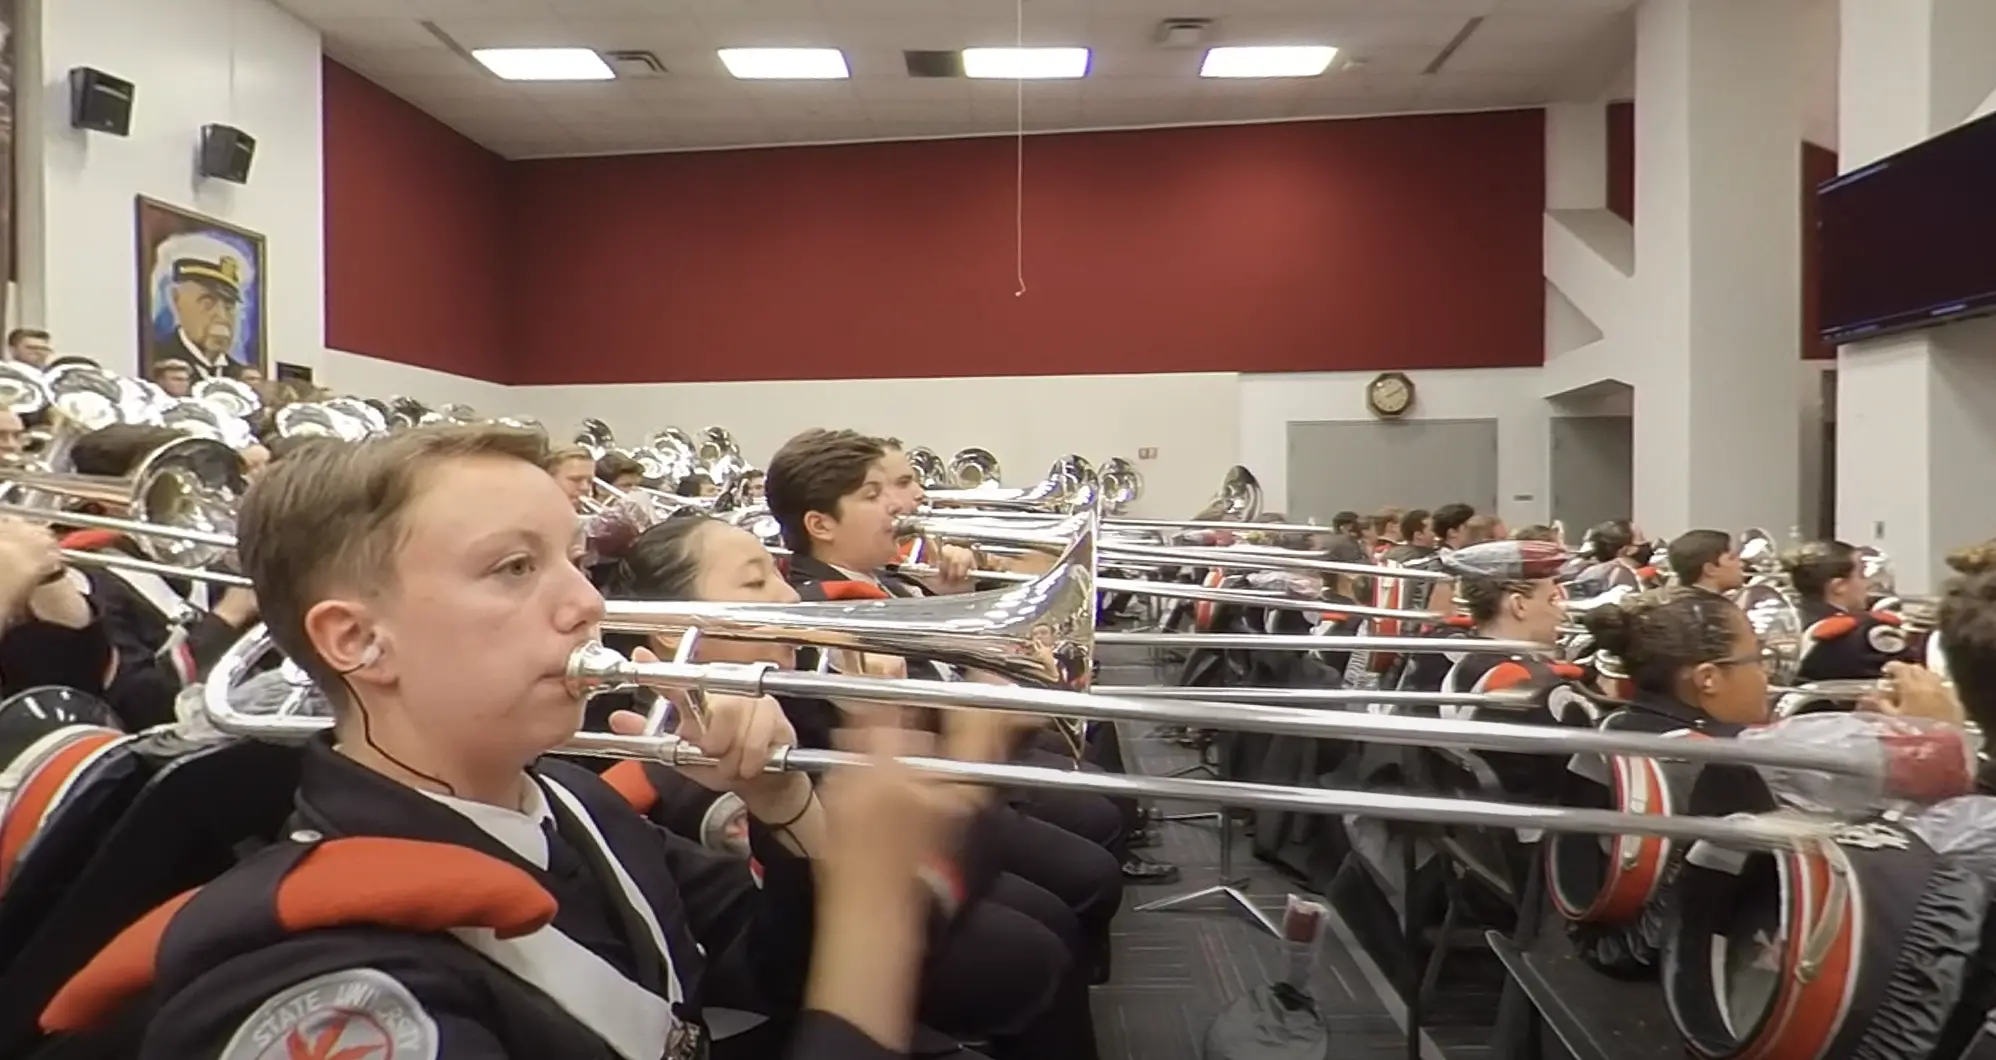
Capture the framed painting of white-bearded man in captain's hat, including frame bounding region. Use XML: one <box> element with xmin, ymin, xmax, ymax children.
<box><xmin>138</xmin><ymin>196</ymin><xmax>269</xmax><ymax>379</ymax></box>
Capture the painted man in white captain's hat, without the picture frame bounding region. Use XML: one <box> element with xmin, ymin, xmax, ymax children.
<box><xmin>146</xmin><ymin>236</ymin><xmax>257</xmax><ymax>379</ymax></box>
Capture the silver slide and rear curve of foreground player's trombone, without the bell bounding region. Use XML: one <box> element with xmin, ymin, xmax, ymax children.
<box><xmin>202</xmin><ymin>627</ymin><xmax>1872</xmax><ymax>850</ymax></box>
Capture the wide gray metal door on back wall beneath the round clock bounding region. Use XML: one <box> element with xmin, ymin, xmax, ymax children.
<box><xmin>1287</xmin><ymin>419</ymin><xmax>1497</xmax><ymax>523</ymax></box>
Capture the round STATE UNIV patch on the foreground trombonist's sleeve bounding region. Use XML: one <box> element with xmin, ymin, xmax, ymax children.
<box><xmin>220</xmin><ymin>968</ymin><xmax>437</xmax><ymax>1060</ymax></box>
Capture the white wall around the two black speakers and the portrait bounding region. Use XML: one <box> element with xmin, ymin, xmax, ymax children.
<box><xmin>8</xmin><ymin>0</ymin><xmax>325</xmax><ymax>379</ymax></box>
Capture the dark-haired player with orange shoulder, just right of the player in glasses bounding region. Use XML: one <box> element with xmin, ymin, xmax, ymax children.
<box><xmin>1780</xmin><ymin>541</ymin><xmax>1918</xmax><ymax>681</ymax></box>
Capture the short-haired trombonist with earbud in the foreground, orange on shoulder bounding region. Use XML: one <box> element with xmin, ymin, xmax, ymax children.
<box><xmin>56</xmin><ymin>427</ymin><xmax>998</xmax><ymax>1060</ymax></box>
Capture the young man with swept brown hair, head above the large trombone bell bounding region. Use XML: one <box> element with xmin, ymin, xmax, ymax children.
<box><xmin>766</xmin><ymin>429</ymin><xmax>1128</xmax><ymax>960</ymax></box>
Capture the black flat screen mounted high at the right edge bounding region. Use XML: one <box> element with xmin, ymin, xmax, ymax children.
<box><xmin>1816</xmin><ymin>116</ymin><xmax>1996</xmax><ymax>343</ymax></box>
